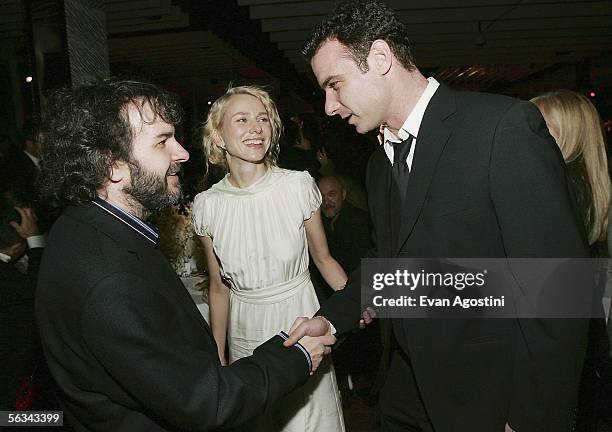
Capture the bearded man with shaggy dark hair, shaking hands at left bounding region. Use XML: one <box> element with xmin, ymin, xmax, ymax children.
<box><xmin>36</xmin><ymin>80</ymin><xmax>334</xmax><ymax>432</ymax></box>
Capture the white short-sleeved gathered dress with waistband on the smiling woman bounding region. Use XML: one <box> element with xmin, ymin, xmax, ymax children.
<box><xmin>193</xmin><ymin>167</ymin><xmax>344</xmax><ymax>432</ymax></box>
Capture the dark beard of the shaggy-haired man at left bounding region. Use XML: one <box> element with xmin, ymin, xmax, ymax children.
<box><xmin>123</xmin><ymin>161</ymin><xmax>181</xmax><ymax>216</ymax></box>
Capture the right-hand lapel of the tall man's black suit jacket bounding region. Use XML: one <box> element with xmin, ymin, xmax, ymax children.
<box><xmin>394</xmin><ymin>84</ymin><xmax>456</xmax><ymax>255</ymax></box>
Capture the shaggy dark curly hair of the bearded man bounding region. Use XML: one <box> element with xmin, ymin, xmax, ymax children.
<box><xmin>38</xmin><ymin>79</ymin><xmax>182</xmax><ymax>207</ymax></box>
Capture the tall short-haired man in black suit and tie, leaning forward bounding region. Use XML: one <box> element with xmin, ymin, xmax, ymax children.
<box><xmin>286</xmin><ymin>0</ymin><xmax>587</xmax><ymax>432</ymax></box>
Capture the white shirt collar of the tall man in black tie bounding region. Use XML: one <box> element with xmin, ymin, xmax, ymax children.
<box><xmin>383</xmin><ymin>77</ymin><xmax>440</xmax><ymax>170</ymax></box>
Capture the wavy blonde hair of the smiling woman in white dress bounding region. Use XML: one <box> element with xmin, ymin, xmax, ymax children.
<box><xmin>202</xmin><ymin>85</ymin><xmax>283</xmax><ymax>171</ymax></box>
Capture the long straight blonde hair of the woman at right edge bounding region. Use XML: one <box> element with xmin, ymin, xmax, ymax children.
<box><xmin>531</xmin><ymin>90</ymin><xmax>610</xmax><ymax>250</ymax></box>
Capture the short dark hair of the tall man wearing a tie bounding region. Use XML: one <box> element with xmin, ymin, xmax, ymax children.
<box><xmin>302</xmin><ymin>0</ymin><xmax>415</xmax><ymax>72</ymax></box>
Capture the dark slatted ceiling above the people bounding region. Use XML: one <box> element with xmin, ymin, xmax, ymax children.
<box><xmin>0</xmin><ymin>0</ymin><xmax>612</xmax><ymax>111</ymax></box>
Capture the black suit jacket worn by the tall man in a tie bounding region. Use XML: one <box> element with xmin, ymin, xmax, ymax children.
<box><xmin>319</xmin><ymin>85</ymin><xmax>588</xmax><ymax>432</ymax></box>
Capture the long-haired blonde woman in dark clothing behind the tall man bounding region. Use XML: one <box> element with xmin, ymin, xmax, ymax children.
<box><xmin>531</xmin><ymin>90</ymin><xmax>612</xmax><ymax>432</ymax></box>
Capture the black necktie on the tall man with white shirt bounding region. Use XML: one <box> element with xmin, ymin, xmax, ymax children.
<box><xmin>389</xmin><ymin>135</ymin><xmax>414</xmax><ymax>246</ymax></box>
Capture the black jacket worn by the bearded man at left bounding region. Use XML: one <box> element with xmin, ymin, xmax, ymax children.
<box><xmin>36</xmin><ymin>204</ymin><xmax>308</xmax><ymax>431</ymax></box>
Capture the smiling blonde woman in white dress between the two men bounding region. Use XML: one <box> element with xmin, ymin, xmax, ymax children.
<box><xmin>193</xmin><ymin>86</ymin><xmax>347</xmax><ymax>432</ymax></box>
